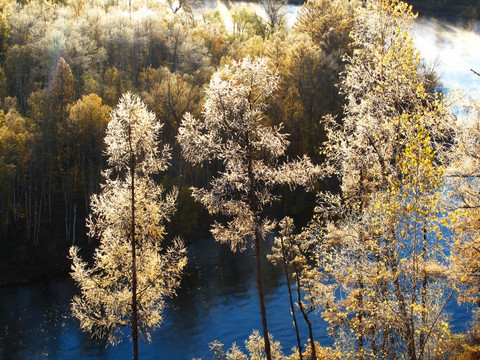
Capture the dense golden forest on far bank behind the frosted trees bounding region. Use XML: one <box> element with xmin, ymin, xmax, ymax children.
<box><xmin>0</xmin><ymin>1</ymin><xmax>353</xmax><ymax>278</ymax></box>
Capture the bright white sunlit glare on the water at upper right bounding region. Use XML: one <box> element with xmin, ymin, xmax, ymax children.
<box><xmin>413</xmin><ymin>17</ymin><xmax>480</xmax><ymax>94</ymax></box>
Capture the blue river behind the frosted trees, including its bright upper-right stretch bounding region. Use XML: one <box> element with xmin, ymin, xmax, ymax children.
<box><xmin>0</xmin><ymin>10</ymin><xmax>480</xmax><ymax>360</ymax></box>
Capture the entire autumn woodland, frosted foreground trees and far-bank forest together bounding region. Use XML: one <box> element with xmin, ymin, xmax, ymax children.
<box><xmin>0</xmin><ymin>0</ymin><xmax>480</xmax><ymax>360</ymax></box>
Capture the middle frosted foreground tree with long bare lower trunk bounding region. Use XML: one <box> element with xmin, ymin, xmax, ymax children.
<box><xmin>178</xmin><ymin>57</ymin><xmax>322</xmax><ymax>360</ymax></box>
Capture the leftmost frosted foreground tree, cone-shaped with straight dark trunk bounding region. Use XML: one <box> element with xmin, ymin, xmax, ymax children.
<box><xmin>70</xmin><ymin>93</ymin><xmax>186</xmax><ymax>359</ymax></box>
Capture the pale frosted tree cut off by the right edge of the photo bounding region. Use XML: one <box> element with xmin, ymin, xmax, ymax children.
<box><xmin>446</xmin><ymin>99</ymin><xmax>480</xmax><ymax>306</ymax></box>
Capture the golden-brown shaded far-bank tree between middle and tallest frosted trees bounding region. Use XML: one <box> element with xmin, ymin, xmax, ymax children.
<box><xmin>265</xmin><ymin>31</ymin><xmax>345</xmax><ymax>160</ymax></box>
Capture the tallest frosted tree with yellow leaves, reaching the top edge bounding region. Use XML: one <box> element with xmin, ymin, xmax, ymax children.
<box><xmin>311</xmin><ymin>0</ymin><xmax>452</xmax><ymax>359</ymax></box>
